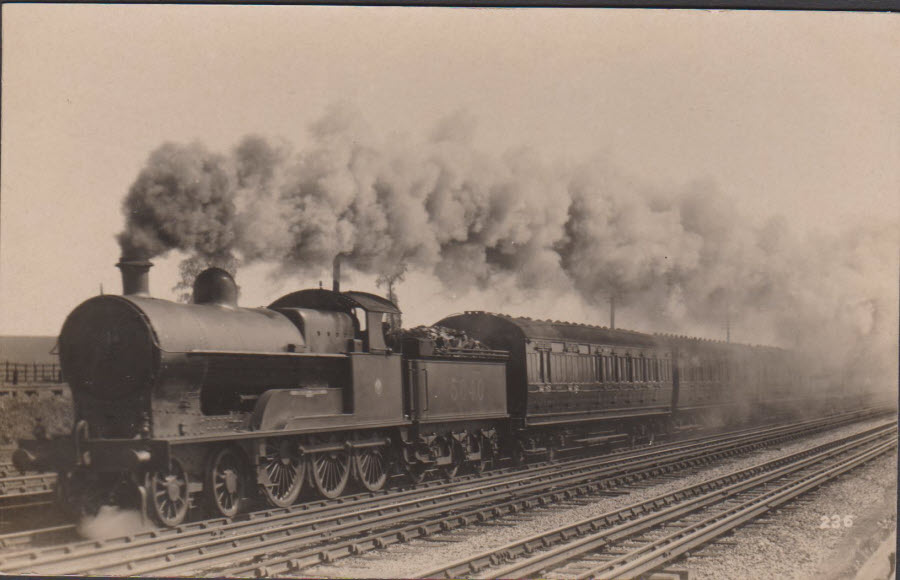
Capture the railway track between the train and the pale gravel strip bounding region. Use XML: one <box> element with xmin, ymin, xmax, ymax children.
<box><xmin>0</xmin><ymin>406</ymin><xmax>884</xmax><ymax>576</ymax></box>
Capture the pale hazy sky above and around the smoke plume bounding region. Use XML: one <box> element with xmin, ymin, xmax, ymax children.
<box><xmin>0</xmin><ymin>4</ymin><xmax>900</xmax><ymax>334</ymax></box>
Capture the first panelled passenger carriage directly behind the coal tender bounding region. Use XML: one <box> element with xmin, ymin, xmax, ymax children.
<box><xmin>437</xmin><ymin>312</ymin><xmax>673</xmax><ymax>455</ymax></box>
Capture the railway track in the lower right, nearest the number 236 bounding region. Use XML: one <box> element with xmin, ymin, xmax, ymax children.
<box><xmin>415</xmin><ymin>422</ymin><xmax>897</xmax><ymax>580</ymax></box>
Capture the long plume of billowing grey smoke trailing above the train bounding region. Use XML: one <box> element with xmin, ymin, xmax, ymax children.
<box><xmin>119</xmin><ymin>107</ymin><xmax>900</xmax><ymax>394</ymax></box>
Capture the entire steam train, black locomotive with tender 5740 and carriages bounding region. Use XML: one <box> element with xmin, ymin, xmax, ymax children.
<box><xmin>13</xmin><ymin>259</ymin><xmax>836</xmax><ymax>526</ymax></box>
